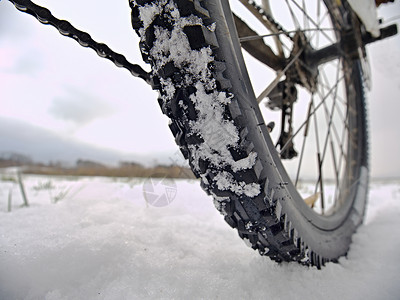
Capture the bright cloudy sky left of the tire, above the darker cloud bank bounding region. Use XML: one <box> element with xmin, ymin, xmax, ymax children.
<box><xmin>0</xmin><ymin>0</ymin><xmax>177</xmax><ymax>166</ymax></box>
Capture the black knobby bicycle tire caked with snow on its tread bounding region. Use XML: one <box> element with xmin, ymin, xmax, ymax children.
<box><xmin>130</xmin><ymin>0</ymin><xmax>368</xmax><ymax>268</ymax></box>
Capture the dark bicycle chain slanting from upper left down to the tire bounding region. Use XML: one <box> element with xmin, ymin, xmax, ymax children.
<box><xmin>9</xmin><ymin>0</ymin><xmax>153</xmax><ymax>86</ymax></box>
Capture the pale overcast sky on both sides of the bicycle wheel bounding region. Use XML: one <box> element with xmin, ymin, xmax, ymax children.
<box><xmin>0</xmin><ymin>0</ymin><xmax>400</xmax><ymax>176</ymax></box>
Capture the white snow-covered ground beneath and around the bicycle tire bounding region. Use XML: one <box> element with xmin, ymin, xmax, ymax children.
<box><xmin>0</xmin><ymin>174</ymin><xmax>400</xmax><ymax>300</ymax></box>
